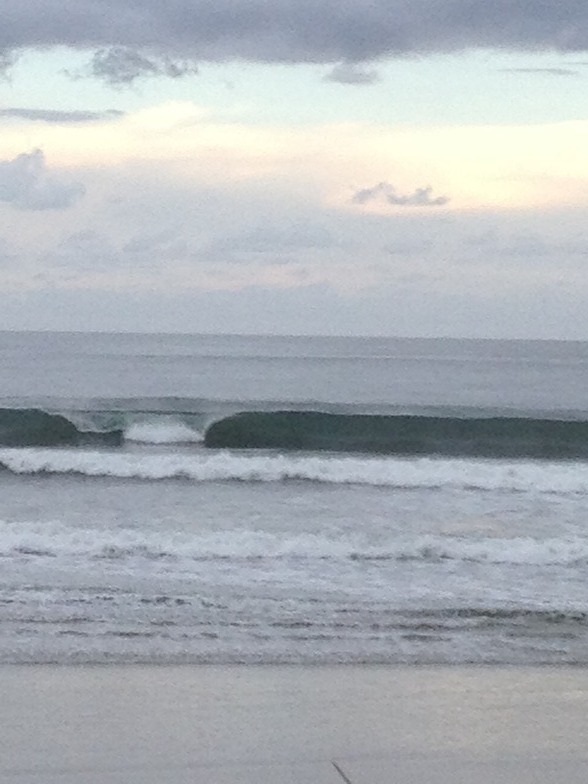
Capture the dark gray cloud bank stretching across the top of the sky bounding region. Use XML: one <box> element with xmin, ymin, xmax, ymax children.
<box><xmin>0</xmin><ymin>0</ymin><xmax>588</xmax><ymax>75</ymax></box>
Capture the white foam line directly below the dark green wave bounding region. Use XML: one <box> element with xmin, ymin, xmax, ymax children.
<box><xmin>0</xmin><ymin>449</ymin><xmax>588</xmax><ymax>494</ymax></box>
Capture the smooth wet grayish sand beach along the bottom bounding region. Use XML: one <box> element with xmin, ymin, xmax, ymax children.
<box><xmin>0</xmin><ymin>665</ymin><xmax>588</xmax><ymax>784</ymax></box>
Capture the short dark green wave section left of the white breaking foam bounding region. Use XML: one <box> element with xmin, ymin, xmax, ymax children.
<box><xmin>0</xmin><ymin>408</ymin><xmax>122</xmax><ymax>447</ymax></box>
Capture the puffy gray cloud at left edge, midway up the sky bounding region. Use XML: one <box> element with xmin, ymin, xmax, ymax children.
<box><xmin>0</xmin><ymin>150</ymin><xmax>85</xmax><ymax>210</ymax></box>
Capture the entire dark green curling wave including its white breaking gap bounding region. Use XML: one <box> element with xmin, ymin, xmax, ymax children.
<box><xmin>0</xmin><ymin>401</ymin><xmax>588</xmax><ymax>460</ymax></box>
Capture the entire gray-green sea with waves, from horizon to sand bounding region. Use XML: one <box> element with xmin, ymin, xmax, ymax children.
<box><xmin>0</xmin><ymin>333</ymin><xmax>588</xmax><ymax>664</ymax></box>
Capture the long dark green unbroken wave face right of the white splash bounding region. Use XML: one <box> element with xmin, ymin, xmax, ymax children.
<box><xmin>205</xmin><ymin>411</ymin><xmax>588</xmax><ymax>458</ymax></box>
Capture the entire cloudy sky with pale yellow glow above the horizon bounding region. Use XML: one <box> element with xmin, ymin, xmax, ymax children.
<box><xmin>0</xmin><ymin>0</ymin><xmax>588</xmax><ymax>340</ymax></box>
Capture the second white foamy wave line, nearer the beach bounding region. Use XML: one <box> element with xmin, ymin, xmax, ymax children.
<box><xmin>0</xmin><ymin>521</ymin><xmax>588</xmax><ymax>566</ymax></box>
